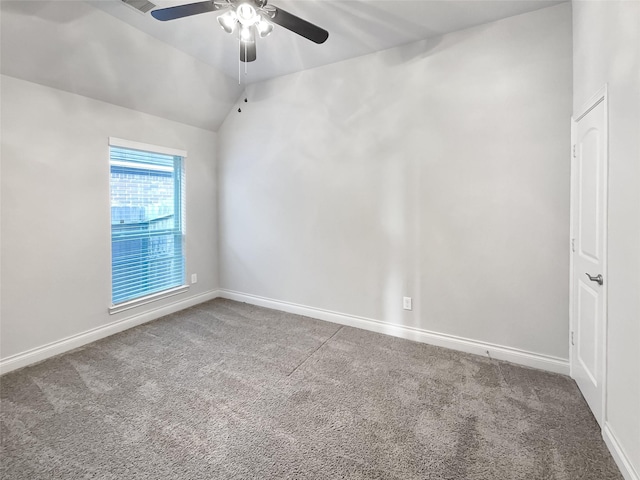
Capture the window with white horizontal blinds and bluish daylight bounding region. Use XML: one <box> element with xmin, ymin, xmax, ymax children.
<box><xmin>109</xmin><ymin>138</ymin><xmax>186</xmax><ymax>313</ymax></box>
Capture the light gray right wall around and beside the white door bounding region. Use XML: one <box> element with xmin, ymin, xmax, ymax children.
<box><xmin>573</xmin><ymin>1</ymin><xmax>640</xmax><ymax>472</ymax></box>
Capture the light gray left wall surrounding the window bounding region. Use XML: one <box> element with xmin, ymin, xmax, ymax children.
<box><xmin>0</xmin><ymin>75</ymin><xmax>218</xmax><ymax>359</ymax></box>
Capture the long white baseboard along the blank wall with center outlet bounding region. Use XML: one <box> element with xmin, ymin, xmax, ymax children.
<box><xmin>219</xmin><ymin>289</ymin><xmax>568</xmax><ymax>376</ymax></box>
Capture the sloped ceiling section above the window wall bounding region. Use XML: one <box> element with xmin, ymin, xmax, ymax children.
<box><xmin>0</xmin><ymin>0</ymin><xmax>243</xmax><ymax>131</ymax></box>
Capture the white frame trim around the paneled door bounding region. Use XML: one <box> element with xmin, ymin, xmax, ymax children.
<box><xmin>569</xmin><ymin>84</ymin><xmax>609</xmax><ymax>429</ymax></box>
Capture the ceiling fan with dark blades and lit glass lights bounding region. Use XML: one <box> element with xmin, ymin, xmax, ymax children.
<box><xmin>151</xmin><ymin>0</ymin><xmax>329</xmax><ymax>62</ymax></box>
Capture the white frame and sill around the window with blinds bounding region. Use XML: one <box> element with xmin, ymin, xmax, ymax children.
<box><xmin>107</xmin><ymin>137</ymin><xmax>189</xmax><ymax>315</ymax></box>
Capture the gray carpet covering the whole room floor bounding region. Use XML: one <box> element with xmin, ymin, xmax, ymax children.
<box><xmin>0</xmin><ymin>299</ymin><xmax>622</xmax><ymax>480</ymax></box>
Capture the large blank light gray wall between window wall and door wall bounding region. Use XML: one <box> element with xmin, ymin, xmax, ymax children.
<box><xmin>219</xmin><ymin>4</ymin><xmax>572</xmax><ymax>359</ymax></box>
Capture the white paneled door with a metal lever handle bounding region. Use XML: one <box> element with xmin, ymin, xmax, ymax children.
<box><xmin>571</xmin><ymin>92</ymin><xmax>608</xmax><ymax>425</ymax></box>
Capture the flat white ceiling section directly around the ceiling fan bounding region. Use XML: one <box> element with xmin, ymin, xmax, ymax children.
<box><xmin>89</xmin><ymin>0</ymin><xmax>564</xmax><ymax>83</ymax></box>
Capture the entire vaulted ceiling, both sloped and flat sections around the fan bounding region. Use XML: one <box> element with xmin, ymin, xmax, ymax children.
<box><xmin>0</xmin><ymin>0</ymin><xmax>562</xmax><ymax>131</ymax></box>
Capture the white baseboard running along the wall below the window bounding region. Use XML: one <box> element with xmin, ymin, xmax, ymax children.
<box><xmin>0</xmin><ymin>290</ymin><xmax>219</xmax><ymax>375</ymax></box>
